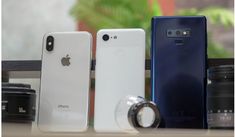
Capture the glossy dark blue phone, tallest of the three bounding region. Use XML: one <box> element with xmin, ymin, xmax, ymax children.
<box><xmin>151</xmin><ymin>16</ymin><xmax>207</xmax><ymax>128</ymax></box>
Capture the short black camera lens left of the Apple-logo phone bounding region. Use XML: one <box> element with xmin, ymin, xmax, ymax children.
<box><xmin>2</xmin><ymin>83</ymin><xmax>36</xmax><ymax>123</ymax></box>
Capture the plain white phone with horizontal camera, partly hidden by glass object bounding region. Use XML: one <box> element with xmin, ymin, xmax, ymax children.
<box><xmin>94</xmin><ymin>29</ymin><xmax>145</xmax><ymax>132</ymax></box>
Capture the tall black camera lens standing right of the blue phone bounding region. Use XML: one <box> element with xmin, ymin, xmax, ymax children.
<box><xmin>207</xmin><ymin>65</ymin><xmax>234</xmax><ymax>129</ymax></box>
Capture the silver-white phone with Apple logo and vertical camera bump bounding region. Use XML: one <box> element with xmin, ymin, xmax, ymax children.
<box><xmin>38</xmin><ymin>32</ymin><xmax>92</xmax><ymax>132</ymax></box>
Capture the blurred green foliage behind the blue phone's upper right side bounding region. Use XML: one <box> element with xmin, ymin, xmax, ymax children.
<box><xmin>177</xmin><ymin>7</ymin><xmax>234</xmax><ymax>58</ymax></box>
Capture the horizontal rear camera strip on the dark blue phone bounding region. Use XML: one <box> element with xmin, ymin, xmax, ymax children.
<box><xmin>167</xmin><ymin>29</ymin><xmax>191</xmax><ymax>37</ymax></box>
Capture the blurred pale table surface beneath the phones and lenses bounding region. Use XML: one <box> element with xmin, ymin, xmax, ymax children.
<box><xmin>2</xmin><ymin>123</ymin><xmax>234</xmax><ymax>137</ymax></box>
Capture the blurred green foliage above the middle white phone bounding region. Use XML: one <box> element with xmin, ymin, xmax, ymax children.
<box><xmin>71</xmin><ymin>0</ymin><xmax>162</xmax><ymax>58</ymax></box>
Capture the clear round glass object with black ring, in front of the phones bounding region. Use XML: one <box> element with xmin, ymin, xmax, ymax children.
<box><xmin>115</xmin><ymin>96</ymin><xmax>161</xmax><ymax>133</ymax></box>
